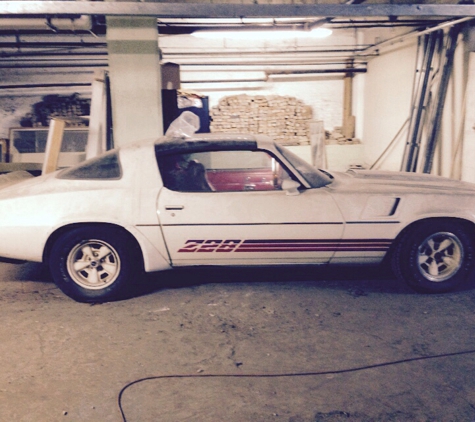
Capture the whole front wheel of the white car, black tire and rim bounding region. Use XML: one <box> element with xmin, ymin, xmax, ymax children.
<box><xmin>393</xmin><ymin>219</ymin><xmax>474</xmax><ymax>293</ymax></box>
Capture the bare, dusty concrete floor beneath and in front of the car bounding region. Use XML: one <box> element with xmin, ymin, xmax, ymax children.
<box><xmin>0</xmin><ymin>264</ymin><xmax>475</xmax><ymax>422</ymax></box>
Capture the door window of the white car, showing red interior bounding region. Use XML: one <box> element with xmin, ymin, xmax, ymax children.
<box><xmin>158</xmin><ymin>150</ymin><xmax>289</xmax><ymax>192</ymax></box>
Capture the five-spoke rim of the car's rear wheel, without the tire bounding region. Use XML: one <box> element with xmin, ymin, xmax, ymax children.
<box><xmin>67</xmin><ymin>240</ymin><xmax>120</xmax><ymax>290</ymax></box>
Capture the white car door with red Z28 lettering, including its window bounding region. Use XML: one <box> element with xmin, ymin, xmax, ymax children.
<box><xmin>157</xmin><ymin>150</ymin><xmax>343</xmax><ymax>265</ymax></box>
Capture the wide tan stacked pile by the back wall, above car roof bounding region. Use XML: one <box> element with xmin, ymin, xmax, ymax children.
<box><xmin>210</xmin><ymin>94</ymin><xmax>312</xmax><ymax>145</ymax></box>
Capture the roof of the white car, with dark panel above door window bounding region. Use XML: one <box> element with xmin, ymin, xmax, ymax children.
<box><xmin>155</xmin><ymin>133</ymin><xmax>272</xmax><ymax>155</ymax></box>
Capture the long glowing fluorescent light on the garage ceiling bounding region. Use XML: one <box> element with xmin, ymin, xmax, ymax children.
<box><xmin>192</xmin><ymin>27</ymin><xmax>332</xmax><ymax>41</ymax></box>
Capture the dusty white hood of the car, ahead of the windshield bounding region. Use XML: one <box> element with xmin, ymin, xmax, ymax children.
<box><xmin>334</xmin><ymin>169</ymin><xmax>475</xmax><ymax>194</ymax></box>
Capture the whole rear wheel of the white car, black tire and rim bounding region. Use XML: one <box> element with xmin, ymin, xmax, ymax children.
<box><xmin>49</xmin><ymin>226</ymin><xmax>141</xmax><ymax>302</ymax></box>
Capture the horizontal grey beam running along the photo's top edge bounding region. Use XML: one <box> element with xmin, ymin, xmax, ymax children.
<box><xmin>0</xmin><ymin>1</ymin><xmax>475</xmax><ymax>18</ymax></box>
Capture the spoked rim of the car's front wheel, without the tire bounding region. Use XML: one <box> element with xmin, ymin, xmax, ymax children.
<box><xmin>418</xmin><ymin>232</ymin><xmax>464</xmax><ymax>283</ymax></box>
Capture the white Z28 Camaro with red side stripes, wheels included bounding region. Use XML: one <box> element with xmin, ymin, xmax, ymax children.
<box><xmin>0</xmin><ymin>134</ymin><xmax>475</xmax><ymax>302</ymax></box>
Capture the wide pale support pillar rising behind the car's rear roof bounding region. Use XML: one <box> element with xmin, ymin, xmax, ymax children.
<box><xmin>107</xmin><ymin>16</ymin><xmax>163</xmax><ymax>146</ymax></box>
